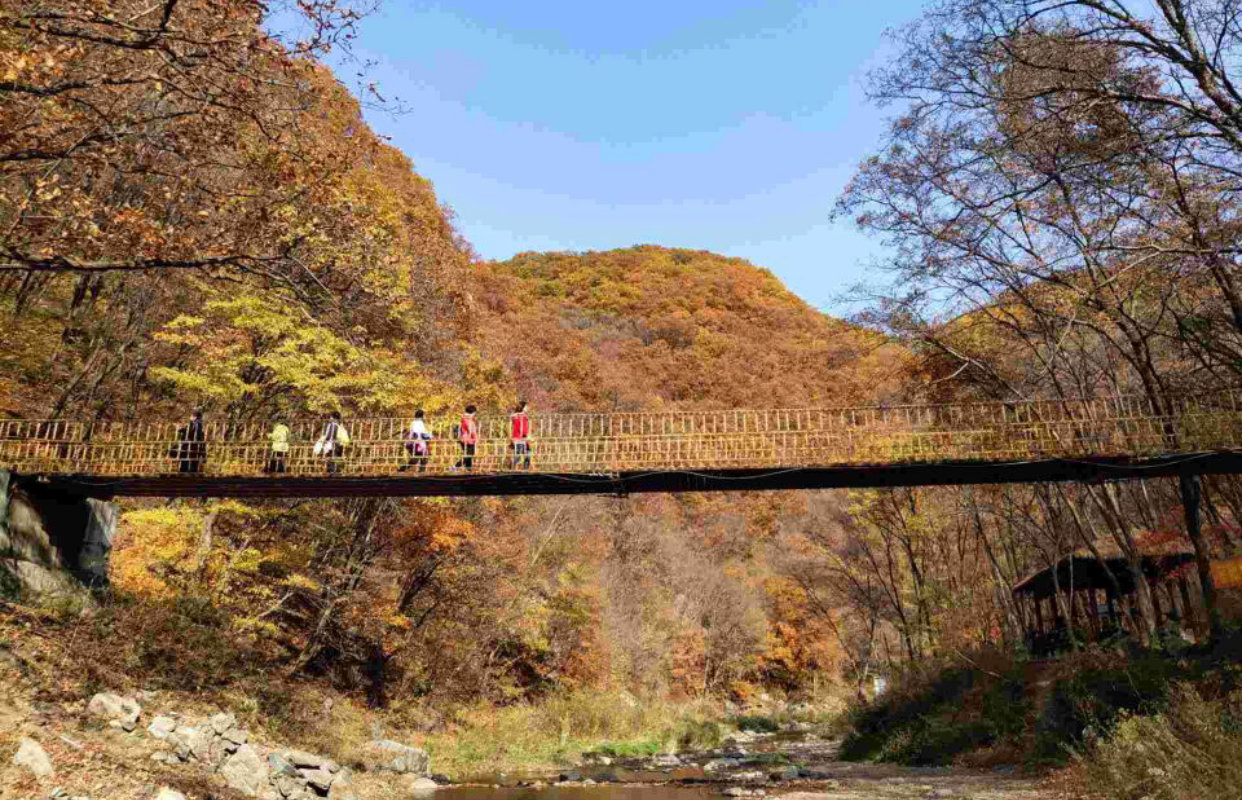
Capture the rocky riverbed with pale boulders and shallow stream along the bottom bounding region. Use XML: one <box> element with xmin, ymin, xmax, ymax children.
<box><xmin>0</xmin><ymin>693</ymin><xmax>1066</xmax><ymax>800</ymax></box>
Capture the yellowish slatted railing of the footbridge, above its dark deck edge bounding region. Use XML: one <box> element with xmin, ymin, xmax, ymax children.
<box><xmin>0</xmin><ymin>393</ymin><xmax>1242</xmax><ymax>477</ymax></box>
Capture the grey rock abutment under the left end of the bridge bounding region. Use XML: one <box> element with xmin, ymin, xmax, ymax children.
<box><xmin>0</xmin><ymin>470</ymin><xmax>117</xmax><ymax>600</ymax></box>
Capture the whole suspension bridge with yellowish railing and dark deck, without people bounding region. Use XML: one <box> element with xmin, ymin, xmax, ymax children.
<box><xmin>0</xmin><ymin>393</ymin><xmax>1242</xmax><ymax>499</ymax></box>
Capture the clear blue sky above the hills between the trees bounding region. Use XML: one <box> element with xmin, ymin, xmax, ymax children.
<box><xmin>315</xmin><ymin>0</ymin><xmax>922</xmax><ymax>311</ymax></box>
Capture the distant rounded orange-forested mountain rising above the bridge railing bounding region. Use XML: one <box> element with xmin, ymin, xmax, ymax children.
<box><xmin>477</xmin><ymin>246</ymin><xmax>902</xmax><ymax>411</ymax></box>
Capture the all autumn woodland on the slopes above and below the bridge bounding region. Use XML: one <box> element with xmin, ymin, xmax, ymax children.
<box><xmin>7</xmin><ymin>0</ymin><xmax>1242</xmax><ymax>800</ymax></box>
